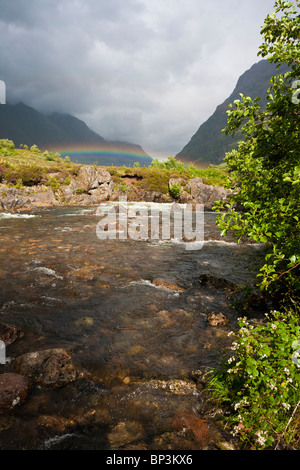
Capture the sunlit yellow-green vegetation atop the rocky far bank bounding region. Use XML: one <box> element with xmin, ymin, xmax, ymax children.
<box><xmin>0</xmin><ymin>139</ymin><xmax>228</xmax><ymax>194</ymax></box>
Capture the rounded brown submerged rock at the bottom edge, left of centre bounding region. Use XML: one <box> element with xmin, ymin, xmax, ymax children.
<box><xmin>108</xmin><ymin>421</ymin><xmax>143</xmax><ymax>448</ymax></box>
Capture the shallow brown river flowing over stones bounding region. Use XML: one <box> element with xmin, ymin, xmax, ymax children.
<box><xmin>0</xmin><ymin>204</ymin><xmax>262</xmax><ymax>450</ymax></box>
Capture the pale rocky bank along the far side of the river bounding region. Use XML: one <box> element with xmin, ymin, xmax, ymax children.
<box><xmin>0</xmin><ymin>165</ymin><xmax>230</xmax><ymax>212</ymax></box>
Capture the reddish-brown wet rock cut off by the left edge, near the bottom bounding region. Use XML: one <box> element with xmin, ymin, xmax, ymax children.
<box><xmin>0</xmin><ymin>373</ymin><xmax>31</xmax><ymax>411</ymax></box>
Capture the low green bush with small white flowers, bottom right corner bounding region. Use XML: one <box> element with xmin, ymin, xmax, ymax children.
<box><xmin>208</xmin><ymin>311</ymin><xmax>300</xmax><ymax>449</ymax></box>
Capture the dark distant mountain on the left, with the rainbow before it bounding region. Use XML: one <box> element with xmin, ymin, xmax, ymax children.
<box><xmin>0</xmin><ymin>102</ymin><xmax>152</xmax><ymax>166</ymax></box>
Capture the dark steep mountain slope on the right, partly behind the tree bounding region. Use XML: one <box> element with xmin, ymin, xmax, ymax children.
<box><xmin>176</xmin><ymin>60</ymin><xmax>287</xmax><ymax>166</ymax></box>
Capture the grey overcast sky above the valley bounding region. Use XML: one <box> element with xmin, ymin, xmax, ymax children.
<box><xmin>0</xmin><ymin>0</ymin><xmax>274</xmax><ymax>156</ymax></box>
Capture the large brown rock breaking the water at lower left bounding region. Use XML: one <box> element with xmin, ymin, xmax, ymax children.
<box><xmin>14</xmin><ymin>348</ymin><xmax>78</xmax><ymax>387</ymax></box>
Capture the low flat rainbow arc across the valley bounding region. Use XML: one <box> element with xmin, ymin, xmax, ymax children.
<box><xmin>51</xmin><ymin>144</ymin><xmax>152</xmax><ymax>166</ymax></box>
